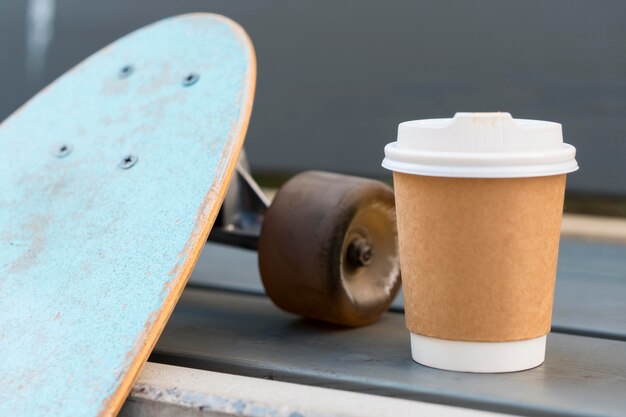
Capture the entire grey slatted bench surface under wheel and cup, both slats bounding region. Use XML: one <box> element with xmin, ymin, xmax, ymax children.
<box><xmin>151</xmin><ymin>240</ymin><xmax>626</xmax><ymax>416</ymax></box>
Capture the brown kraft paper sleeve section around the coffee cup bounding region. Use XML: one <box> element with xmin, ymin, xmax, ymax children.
<box><xmin>393</xmin><ymin>172</ymin><xmax>566</xmax><ymax>342</ymax></box>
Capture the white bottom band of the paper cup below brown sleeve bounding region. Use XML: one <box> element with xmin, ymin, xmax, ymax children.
<box><xmin>411</xmin><ymin>333</ymin><xmax>546</xmax><ymax>373</ymax></box>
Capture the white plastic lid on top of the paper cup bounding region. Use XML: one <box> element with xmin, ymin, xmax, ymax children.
<box><xmin>382</xmin><ymin>112</ymin><xmax>578</xmax><ymax>178</ymax></box>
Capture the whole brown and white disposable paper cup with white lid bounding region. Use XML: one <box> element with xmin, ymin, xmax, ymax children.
<box><xmin>383</xmin><ymin>113</ymin><xmax>578</xmax><ymax>372</ymax></box>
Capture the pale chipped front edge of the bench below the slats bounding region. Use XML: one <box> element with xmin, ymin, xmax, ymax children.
<box><xmin>120</xmin><ymin>362</ymin><xmax>505</xmax><ymax>417</ymax></box>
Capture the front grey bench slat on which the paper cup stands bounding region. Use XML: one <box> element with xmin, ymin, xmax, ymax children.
<box><xmin>151</xmin><ymin>288</ymin><xmax>626</xmax><ymax>416</ymax></box>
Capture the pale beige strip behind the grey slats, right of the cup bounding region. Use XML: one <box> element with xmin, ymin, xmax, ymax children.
<box><xmin>561</xmin><ymin>214</ymin><xmax>626</xmax><ymax>244</ymax></box>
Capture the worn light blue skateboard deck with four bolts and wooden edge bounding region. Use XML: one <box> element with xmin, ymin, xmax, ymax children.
<box><xmin>0</xmin><ymin>14</ymin><xmax>256</xmax><ymax>416</ymax></box>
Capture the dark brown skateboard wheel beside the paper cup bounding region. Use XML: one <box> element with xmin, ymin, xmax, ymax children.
<box><xmin>258</xmin><ymin>171</ymin><xmax>400</xmax><ymax>326</ymax></box>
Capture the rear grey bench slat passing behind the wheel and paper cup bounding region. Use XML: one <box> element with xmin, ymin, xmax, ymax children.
<box><xmin>190</xmin><ymin>239</ymin><xmax>626</xmax><ymax>341</ymax></box>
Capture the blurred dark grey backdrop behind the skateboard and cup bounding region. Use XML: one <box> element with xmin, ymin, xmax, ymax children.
<box><xmin>0</xmin><ymin>0</ymin><xmax>626</xmax><ymax>197</ymax></box>
